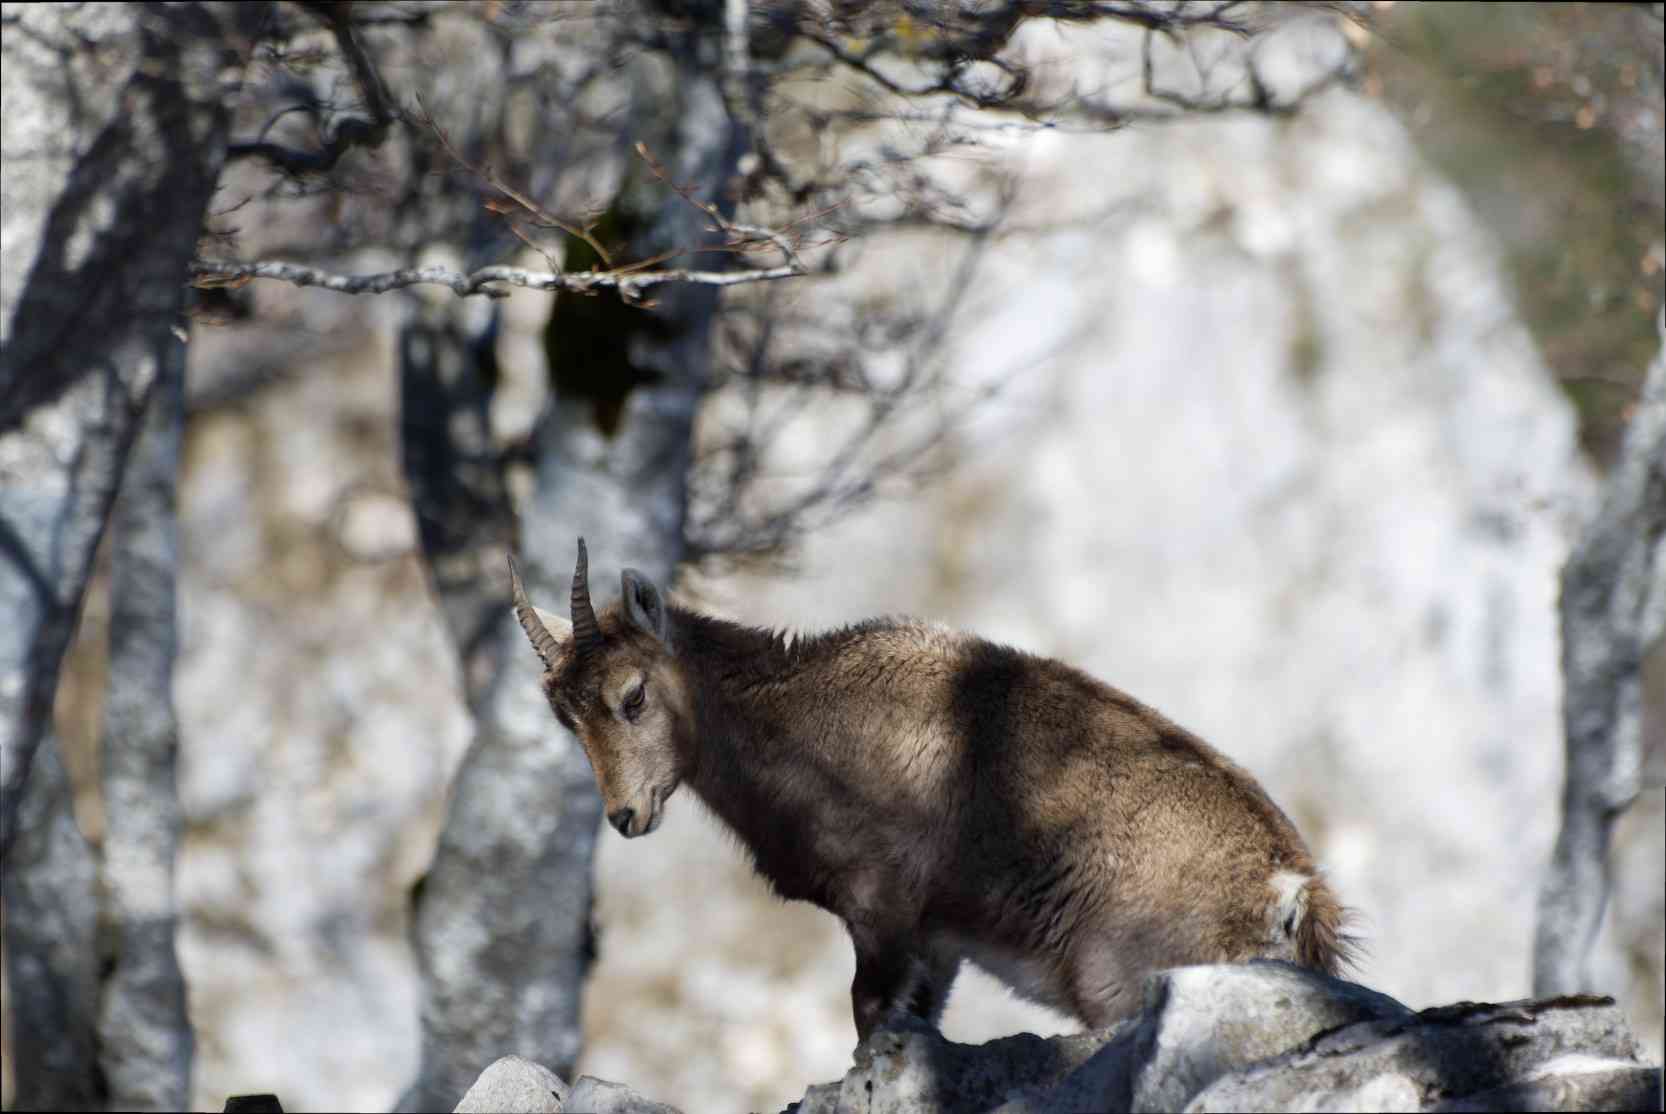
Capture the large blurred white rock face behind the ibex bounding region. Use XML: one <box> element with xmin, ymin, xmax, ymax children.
<box><xmin>585</xmin><ymin>87</ymin><xmax>1661</xmax><ymax>1109</ymax></box>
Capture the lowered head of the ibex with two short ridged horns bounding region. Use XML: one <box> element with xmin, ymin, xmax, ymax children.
<box><xmin>510</xmin><ymin>538</ymin><xmax>691</xmax><ymax>838</ymax></box>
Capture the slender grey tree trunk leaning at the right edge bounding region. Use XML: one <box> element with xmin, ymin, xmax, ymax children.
<box><xmin>1533</xmin><ymin>318</ymin><xmax>1666</xmax><ymax>997</ymax></box>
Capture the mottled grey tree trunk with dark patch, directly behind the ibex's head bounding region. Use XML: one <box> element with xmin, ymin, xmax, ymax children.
<box><xmin>400</xmin><ymin>22</ymin><xmax>743</xmax><ymax>1111</ymax></box>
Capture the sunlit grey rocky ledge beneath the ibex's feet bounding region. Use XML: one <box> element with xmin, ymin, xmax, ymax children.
<box><xmin>456</xmin><ymin>962</ymin><xmax>1661</xmax><ymax>1114</ymax></box>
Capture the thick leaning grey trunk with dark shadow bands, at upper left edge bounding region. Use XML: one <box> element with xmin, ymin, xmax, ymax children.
<box><xmin>0</xmin><ymin>3</ymin><xmax>253</xmax><ymax>859</ymax></box>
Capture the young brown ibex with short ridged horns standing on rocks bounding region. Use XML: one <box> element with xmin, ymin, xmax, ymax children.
<box><xmin>510</xmin><ymin>540</ymin><xmax>1351</xmax><ymax>1039</ymax></box>
